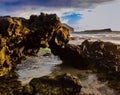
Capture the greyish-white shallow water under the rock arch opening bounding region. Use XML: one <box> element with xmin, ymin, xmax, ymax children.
<box><xmin>17</xmin><ymin>49</ymin><xmax>62</xmax><ymax>84</ymax></box>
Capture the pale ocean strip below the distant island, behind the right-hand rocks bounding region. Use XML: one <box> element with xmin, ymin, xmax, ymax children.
<box><xmin>69</xmin><ymin>31</ymin><xmax>120</xmax><ymax>44</ymax></box>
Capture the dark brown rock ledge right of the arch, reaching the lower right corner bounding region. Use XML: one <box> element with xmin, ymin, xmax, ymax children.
<box><xmin>51</xmin><ymin>40</ymin><xmax>120</xmax><ymax>91</ymax></box>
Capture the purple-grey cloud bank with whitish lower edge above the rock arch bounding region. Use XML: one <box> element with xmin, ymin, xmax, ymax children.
<box><xmin>0</xmin><ymin>0</ymin><xmax>113</xmax><ymax>18</ymax></box>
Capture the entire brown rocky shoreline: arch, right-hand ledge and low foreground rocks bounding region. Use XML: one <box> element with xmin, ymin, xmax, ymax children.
<box><xmin>0</xmin><ymin>13</ymin><xmax>120</xmax><ymax>95</ymax></box>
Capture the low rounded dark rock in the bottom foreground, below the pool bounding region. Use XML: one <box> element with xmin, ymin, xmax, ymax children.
<box><xmin>23</xmin><ymin>73</ymin><xmax>81</xmax><ymax>95</ymax></box>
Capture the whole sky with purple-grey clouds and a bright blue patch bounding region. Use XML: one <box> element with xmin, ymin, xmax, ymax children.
<box><xmin>0</xmin><ymin>0</ymin><xmax>120</xmax><ymax>31</ymax></box>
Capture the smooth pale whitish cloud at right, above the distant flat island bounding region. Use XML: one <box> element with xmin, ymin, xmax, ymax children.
<box><xmin>73</xmin><ymin>1</ymin><xmax>120</xmax><ymax>30</ymax></box>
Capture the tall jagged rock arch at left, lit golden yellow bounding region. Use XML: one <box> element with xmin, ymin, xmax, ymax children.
<box><xmin>0</xmin><ymin>13</ymin><xmax>69</xmax><ymax>76</ymax></box>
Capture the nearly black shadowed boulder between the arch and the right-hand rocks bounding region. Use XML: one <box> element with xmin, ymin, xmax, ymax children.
<box><xmin>51</xmin><ymin>44</ymin><xmax>88</xmax><ymax>69</ymax></box>
